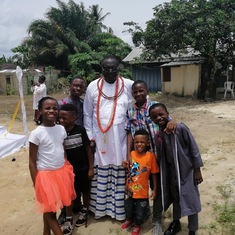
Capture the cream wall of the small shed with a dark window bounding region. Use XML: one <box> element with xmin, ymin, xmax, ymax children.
<box><xmin>162</xmin><ymin>64</ymin><xmax>201</xmax><ymax>98</ymax></box>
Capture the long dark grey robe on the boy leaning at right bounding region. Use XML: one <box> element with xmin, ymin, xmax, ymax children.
<box><xmin>155</xmin><ymin>123</ymin><xmax>203</xmax><ymax>217</ymax></box>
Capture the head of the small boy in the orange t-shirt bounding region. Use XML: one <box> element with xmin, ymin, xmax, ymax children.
<box><xmin>134</xmin><ymin>129</ymin><xmax>149</xmax><ymax>154</ymax></box>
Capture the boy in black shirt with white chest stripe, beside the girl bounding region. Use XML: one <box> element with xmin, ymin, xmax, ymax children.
<box><xmin>59</xmin><ymin>104</ymin><xmax>94</xmax><ymax>235</ymax></box>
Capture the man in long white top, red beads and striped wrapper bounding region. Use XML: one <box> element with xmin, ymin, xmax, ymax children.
<box><xmin>83</xmin><ymin>55</ymin><xmax>133</xmax><ymax>221</ymax></box>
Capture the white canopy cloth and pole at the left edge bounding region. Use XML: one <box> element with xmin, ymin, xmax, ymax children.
<box><xmin>0</xmin><ymin>66</ymin><xmax>28</xmax><ymax>158</ymax></box>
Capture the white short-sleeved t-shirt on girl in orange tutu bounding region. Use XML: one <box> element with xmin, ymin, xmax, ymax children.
<box><xmin>29</xmin><ymin>125</ymin><xmax>67</xmax><ymax>170</ymax></box>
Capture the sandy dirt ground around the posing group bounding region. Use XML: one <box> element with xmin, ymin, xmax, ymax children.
<box><xmin>0</xmin><ymin>94</ymin><xmax>235</xmax><ymax>235</ymax></box>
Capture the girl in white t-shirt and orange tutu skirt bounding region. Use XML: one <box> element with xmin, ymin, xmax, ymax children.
<box><xmin>29</xmin><ymin>97</ymin><xmax>76</xmax><ymax>235</ymax></box>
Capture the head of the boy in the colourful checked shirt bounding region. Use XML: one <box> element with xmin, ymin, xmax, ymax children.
<box><xmin>132</xmin><ymin>80</ymin><xmax>148</xmax><ymax>105</ymax></box>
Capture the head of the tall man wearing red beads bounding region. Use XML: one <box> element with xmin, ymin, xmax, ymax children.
<box><xmin>102</xmin><ymin>58</ymin><xmax>119</xmax><ymax>83</ymax></box>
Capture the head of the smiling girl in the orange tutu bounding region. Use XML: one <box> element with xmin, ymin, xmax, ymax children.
<box><xmin>38</xmin><ymin>96</ymin><xmax>59</xmax><ymax>125</ymax></box>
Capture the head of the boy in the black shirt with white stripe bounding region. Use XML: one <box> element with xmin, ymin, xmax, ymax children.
<box><xmin>59</xmin><ymin>104</ymin><xmax>78</xmax><ymax>129</ymax></box>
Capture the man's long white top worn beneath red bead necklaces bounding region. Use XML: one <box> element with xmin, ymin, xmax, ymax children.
<box><xmin>83</xmin><ymin>78</ymin><xmax>133</xmax><ymax>166</ymax></box>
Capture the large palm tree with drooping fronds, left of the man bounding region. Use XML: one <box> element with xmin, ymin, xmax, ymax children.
<box><xmin>13</xmin><ymin>0</ymin><xmax>110</xmax><ymax>72</ymax></box>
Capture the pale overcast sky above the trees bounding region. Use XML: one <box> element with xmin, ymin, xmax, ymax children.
<box><xmin>0</xmin><ymin>0</ymin><xmax>170</xmax><ymax>57</ymax></box>
